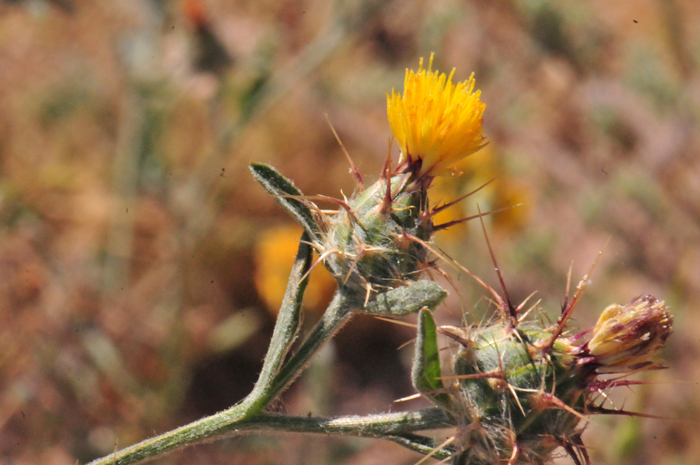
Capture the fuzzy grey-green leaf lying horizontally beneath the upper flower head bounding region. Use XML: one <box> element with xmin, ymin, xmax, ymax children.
<box><xmin>361</xmin><ymin>281</ymin><xmax>447</xmax><ymax>316</ymax></box>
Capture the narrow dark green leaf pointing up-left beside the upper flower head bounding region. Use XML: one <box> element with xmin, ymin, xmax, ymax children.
<box><xmin>250</xmin><ymin>163</ymin><xmax>319</xmax><ymax>241</ymax></box>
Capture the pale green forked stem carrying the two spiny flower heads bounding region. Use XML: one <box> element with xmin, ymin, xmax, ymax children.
<box><xmin>89</xmin><ymin>239</ymin><xmax>449</xmax><ymax>465</ymax></box>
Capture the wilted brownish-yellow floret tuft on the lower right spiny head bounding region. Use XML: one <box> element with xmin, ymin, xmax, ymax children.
<box><xmin>588</xmin><ymin>295</ymin><xmax>673</xmax><ymax>372</ymax></box>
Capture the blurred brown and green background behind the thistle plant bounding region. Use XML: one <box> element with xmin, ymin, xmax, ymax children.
<box><xmin>0</xmin><ymin>0</ymin><xmax>700</xmax><ymax>465</ymax></box>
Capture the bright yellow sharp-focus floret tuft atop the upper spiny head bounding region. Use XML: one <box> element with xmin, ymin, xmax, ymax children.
<box><xmin>387</xmin><ymin>54</ymin><xmax>486</xmax><ymax>176</ymax></box>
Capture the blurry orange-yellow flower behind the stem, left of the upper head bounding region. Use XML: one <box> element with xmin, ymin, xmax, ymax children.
<box><xmin>255</xmin><ymin>225</ymin><xmax>336</xmax><ymax>315</ymax></box>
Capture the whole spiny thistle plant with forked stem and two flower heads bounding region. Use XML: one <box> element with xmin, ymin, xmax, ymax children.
<box><xmin>87</xmin><ymin>56</ymin><xmax>673</xmax><ymax>465</ymax></box>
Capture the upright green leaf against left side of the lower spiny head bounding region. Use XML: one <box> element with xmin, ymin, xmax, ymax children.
<box><xmin>411</xmin><ymin>308</ymin><xmax>452</xmax><ymax>406</ymax></box>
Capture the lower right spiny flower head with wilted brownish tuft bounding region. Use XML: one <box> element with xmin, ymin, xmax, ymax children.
<box><xmin>413</xmin><ymin>288</ymin><xmax>673</xmax><ymax>465</ymax></box>
